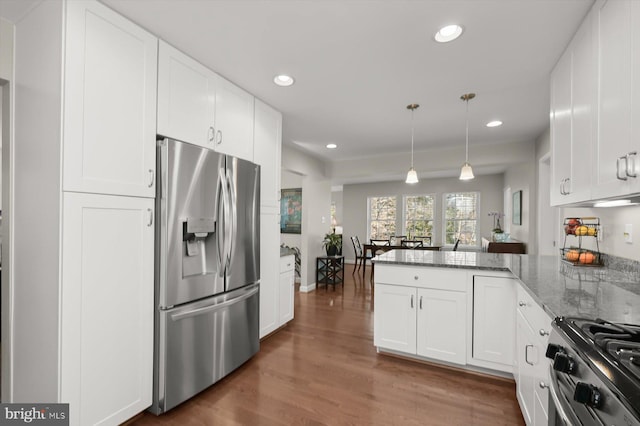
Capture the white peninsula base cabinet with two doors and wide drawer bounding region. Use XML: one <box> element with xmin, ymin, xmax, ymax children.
<box><xmin>373</xmin><ymin>265</ymin><xmax>468</xmax><ymax>365</ymax></box>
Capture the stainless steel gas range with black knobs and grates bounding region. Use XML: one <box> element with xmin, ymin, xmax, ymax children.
<box><xmin>547</xmin><ymin>318</ymin><xmax>640</xmax><ymax>426</ymax></box>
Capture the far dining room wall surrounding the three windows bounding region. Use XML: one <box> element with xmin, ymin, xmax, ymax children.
<box><xmin>343</xmin><ymin>174</ymin><xmax>503</xmax><ymax>260</ymax></box>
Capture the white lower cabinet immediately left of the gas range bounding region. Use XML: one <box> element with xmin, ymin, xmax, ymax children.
<box><xmin>514</xmin><ymin>286</ymin><xmax>552</xmax><ymax>426</ymax></box>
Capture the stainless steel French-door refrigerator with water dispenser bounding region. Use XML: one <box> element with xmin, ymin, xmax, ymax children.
<box><xmin>150</xmin><ymin>139</ymin><xmax>260</xmax><ymax>414</ymax></box>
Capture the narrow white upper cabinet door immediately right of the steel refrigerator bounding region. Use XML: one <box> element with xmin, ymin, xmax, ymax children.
<box><xmin>253</xmin><ymin>99</ymin><xmax>282</xmax><ymax>211</ymax></box>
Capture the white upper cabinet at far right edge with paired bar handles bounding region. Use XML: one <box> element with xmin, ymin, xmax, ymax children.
<box><xmin>593</xmin><ymin>0</ymin><xmax>640</xmax><ymax>198</ymax></box>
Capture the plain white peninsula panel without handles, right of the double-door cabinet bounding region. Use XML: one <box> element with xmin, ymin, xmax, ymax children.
<box><xmin>469</xmin><ymin>275</ymin><xmax>518</xmax><ymax>373</ymax></box>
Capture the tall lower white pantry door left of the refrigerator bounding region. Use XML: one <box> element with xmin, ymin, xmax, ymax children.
<box><xmin>60</xmin><ymin>192</ymin><xmax>154</xmax><ymax>425</ymax></box>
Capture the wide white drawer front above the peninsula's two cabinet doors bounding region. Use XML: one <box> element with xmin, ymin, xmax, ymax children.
<box><xmin>374</xmin><ymin>264</ymin><xmax>467</xmax><ymax>292</ymax></box>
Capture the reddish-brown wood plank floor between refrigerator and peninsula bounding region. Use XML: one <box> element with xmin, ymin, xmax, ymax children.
<box><xmin>132</xmin><ymin>265</ymin><xmax>524</xmax><ymax>426</ymax></box>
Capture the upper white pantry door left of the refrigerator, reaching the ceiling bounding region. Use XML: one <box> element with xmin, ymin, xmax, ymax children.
<box><xmin>63</xmin><ymin>1</ymin><xmax>158</xmax><ymax>197</ymax></box>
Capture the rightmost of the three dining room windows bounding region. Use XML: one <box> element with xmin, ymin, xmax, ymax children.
<box><xmin>444</xmin><ymin>192</ymin><xmax>480</xmax><ymax>246</ymax></box>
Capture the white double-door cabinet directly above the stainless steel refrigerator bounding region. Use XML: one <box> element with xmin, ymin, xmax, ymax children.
<box><xmin>157</xmin><ymin>41</ymin><xmax>254</xmax><ymax>161</ymax></box>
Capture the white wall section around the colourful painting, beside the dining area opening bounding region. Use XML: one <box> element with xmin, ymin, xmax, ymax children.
<box><xmin>282</xmin><ymin>145</ymin><xmax>331</xmax><ymax>292</ymax></box>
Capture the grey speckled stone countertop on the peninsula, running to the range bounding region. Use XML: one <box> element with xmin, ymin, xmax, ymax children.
<box><xmin>374</xmin><ymin>250</ymin><xmax>640</xmax><ymax>324</ymax></box>
